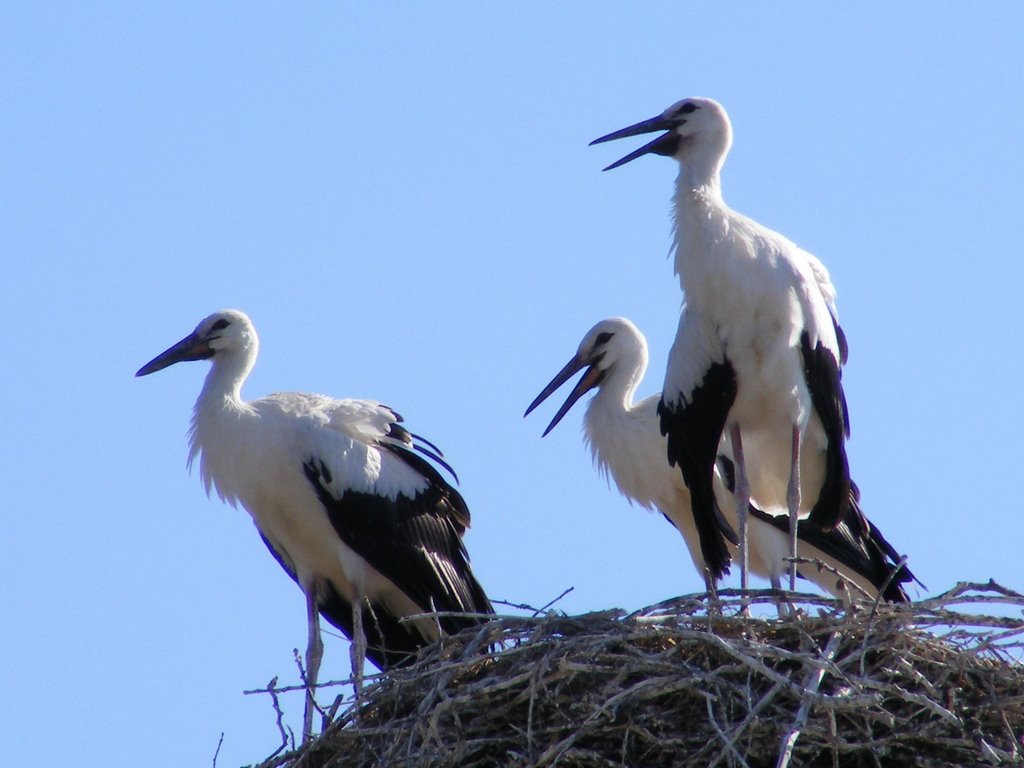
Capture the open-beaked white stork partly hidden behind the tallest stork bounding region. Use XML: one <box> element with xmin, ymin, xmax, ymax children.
<box><xmin>525</xmin><ymin>317</ymin><xmax>913</xmax><ymax>601</ymax></box>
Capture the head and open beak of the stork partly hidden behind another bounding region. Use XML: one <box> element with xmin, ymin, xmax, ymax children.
<box><xmin>523</xmin><ymin>317</ymin><xmax>647</xmax><ymax>435</ymax></box>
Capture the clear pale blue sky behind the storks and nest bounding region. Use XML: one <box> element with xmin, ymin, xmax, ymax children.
<box><xmin>0</xmin><ymin>2</ymin><xmax>1024</xmax><ymax>768</ymax></box>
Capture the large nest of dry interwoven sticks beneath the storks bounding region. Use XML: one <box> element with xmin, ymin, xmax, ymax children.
<box><xmin>249</xmin><ymin>583</ymin><xmax>1024</xmax><ymax>768</ymax></box>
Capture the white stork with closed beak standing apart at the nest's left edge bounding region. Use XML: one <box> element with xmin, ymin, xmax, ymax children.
<box><xmin>135</xmin><ymin>309</ymin><xmax>494</xmax><ymax>738</ymax></box>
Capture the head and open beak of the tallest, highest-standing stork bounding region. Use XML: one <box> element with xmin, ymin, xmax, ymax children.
<box><xmin>590</xmin><ymin>98</ymin><xmax>732</xmax><ymax>171</ymax></box>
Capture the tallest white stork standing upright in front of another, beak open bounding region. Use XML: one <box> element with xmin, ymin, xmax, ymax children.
<box><xmin>592</xmin><ymin>98</ymin><xmax>867</xmax><ymax>588</ymax></box>
